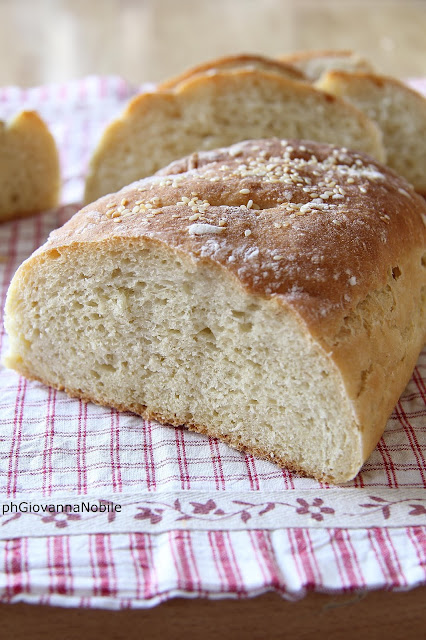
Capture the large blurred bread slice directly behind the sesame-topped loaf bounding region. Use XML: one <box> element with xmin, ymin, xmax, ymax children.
<box><xmin>85</xmin><ymin>69</ymin><xmax>384</xmax><ymax>202</ymax></box>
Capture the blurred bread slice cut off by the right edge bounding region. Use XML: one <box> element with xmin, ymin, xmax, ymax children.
<box><xmin>316</xmin><ymin>71</ymin><xmax>426</xmax><ymax>195</ymax></box>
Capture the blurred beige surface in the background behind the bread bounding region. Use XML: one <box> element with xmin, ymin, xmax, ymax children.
<box><xmin>0</xmin><ymin>0</ymin><xmax>426</xmax><ymax>86</ymax></box>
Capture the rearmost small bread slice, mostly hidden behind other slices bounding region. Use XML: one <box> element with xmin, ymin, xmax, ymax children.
<box><xmin>278</xmin><ymin>50</ymin><xmax>374</xmax><ymax>82</ymax></box>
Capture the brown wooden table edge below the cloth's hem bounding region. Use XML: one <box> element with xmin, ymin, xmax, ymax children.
<box><xmin>0</xmin><ymin>588</ymin><xmax>426</xmax><ymax>640</ymax></box>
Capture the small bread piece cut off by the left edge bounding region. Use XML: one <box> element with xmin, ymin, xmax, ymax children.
<box><xmin>0</xmin><ymin>111</ymin><xmax>60</xmax><ymax>221</ymax></box>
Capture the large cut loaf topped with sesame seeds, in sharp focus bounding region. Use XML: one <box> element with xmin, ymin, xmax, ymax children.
<box><xmin>6</xmin><ymin>140</ymin><xmax>426</xmax><ymax>482</ymax></box>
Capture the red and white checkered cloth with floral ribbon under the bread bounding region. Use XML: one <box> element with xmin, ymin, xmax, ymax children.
<box><xmin>0</xmin><ymin>77</ymin><xmax>426</xmax><ymax>608</ymax></box>
